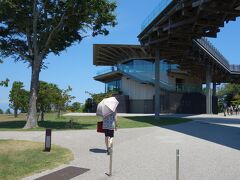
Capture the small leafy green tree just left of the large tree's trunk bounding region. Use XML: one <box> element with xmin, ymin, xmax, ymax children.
<box><xmin>9</xmin><ymin>81</ymin><xmax>29</xmax><ymax>117</ymax></box>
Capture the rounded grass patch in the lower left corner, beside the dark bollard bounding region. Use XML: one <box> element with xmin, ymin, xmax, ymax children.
<box><xmin>0</xmin><ymin>140</ymin><xmax>73</xmax><ymax>180</ymax></box>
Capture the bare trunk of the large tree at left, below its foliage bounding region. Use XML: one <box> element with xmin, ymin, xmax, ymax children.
<box><xmin>24</xmin><ymin>57</ymin><xmax>42</xmax><ymax>129</ymax></box>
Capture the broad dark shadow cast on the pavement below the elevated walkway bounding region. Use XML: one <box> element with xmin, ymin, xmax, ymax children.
<box><xmin>162</xmin><ymin>118</ymin><xmax>240</xmax><ymax>150</ymax></box>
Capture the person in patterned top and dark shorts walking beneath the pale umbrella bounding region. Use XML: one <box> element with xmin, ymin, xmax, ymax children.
<box><xmin>103</xmin><ymin>111</ymin><xmax>118</xmax><ymax>155</ymax></box>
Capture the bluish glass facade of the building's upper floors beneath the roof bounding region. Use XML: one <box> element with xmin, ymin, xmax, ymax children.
<box><xmin>97</xmin><ymin>59</ymin><xmax>201</xmax><ymax>92</ymax></box>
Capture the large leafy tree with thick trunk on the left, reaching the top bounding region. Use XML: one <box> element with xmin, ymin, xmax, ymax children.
<box><xmin>0</xmin><ymin>0</ymin><xmax>116</xmax><ymax>128</ymax></box>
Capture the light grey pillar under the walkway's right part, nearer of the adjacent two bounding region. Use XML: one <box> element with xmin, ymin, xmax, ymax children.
<box><xmin>206</xmin><ymin>65</ymin><xmax>212</xmax><ymax>114</ymax></box>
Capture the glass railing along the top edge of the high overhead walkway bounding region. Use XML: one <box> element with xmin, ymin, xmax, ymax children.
<box><xmin>141</xmin><ymin>0</ymin><xmax>172</xmax><ymax>31</ymax></box>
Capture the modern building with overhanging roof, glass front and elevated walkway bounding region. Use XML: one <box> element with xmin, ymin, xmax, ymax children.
<box><xmin>93</xmin><ymin>0</ymin><xmax>240</xmax><ymax>114</ymax></box>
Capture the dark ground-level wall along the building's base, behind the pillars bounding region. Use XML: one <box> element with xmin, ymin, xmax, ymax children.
<box><xmin>129</xmin><ymin>92</ymin><xmax>217</xmax><ymax>114</ymax></box>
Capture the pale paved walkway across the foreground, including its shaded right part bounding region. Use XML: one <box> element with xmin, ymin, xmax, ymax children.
<box><xmin>0</xmin><ymin>115</ymin><xmax>240</xmax><ymax>180</ymax></box>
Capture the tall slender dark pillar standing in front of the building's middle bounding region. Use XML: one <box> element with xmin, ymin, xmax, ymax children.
<box><xmin>155</xmin><ymin>50</ymin><xmax>160</xmax><ymax>119</ymax></box>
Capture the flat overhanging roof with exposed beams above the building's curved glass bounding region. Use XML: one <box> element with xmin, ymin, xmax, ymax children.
<box><xmin>93</xmin><ymin>44</ymin><xmax>154</xmax><ymax>66</ymax></box>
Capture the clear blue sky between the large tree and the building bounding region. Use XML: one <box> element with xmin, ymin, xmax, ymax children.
<box><xmin>0</xmin><ymin>0</ymin><xmax>240</xmax><ymax>110</ymax></box>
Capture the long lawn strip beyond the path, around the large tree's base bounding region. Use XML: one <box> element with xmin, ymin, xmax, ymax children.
<box><xmin>0</xmin><ymin>113</ymin><xmax>191</xmax><ymax>131</ymax></box>
